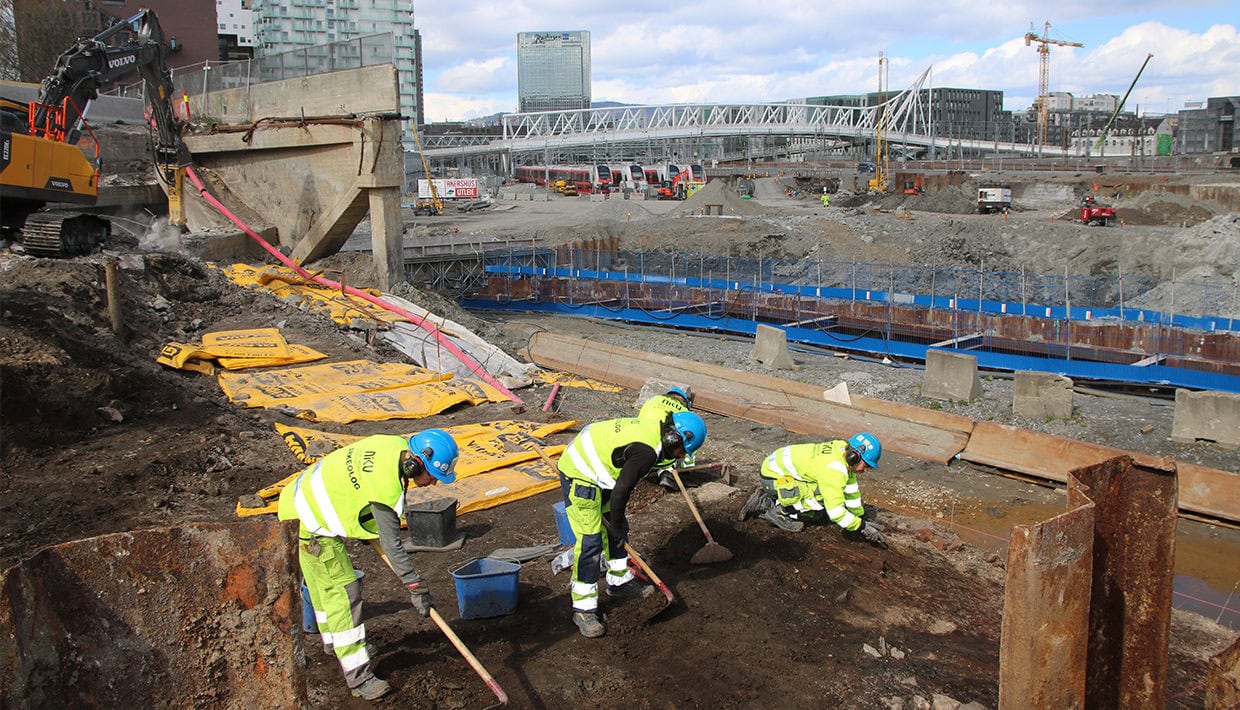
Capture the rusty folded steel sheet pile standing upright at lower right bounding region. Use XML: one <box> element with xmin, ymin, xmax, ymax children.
<box><xmin>999</xmin><ymin>456</ymin><xmax>1178</xmax><ymax>710</ymax></box>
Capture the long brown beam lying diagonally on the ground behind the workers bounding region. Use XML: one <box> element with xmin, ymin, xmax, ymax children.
<box><xmin>529</xmin><ymin>331</ymin><xmax>1240</xmax><ymax>523</ymax></box>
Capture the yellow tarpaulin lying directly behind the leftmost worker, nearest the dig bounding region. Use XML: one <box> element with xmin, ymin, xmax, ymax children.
<box><xmin>237</xmin><ymin>420</ymin><xmax>577</xmax><ymax>518</ymax></box>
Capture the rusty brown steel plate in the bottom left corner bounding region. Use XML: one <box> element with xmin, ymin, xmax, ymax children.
<box><xmin>0</xmin><ymin>519</ymin><xmax>306</xmax><ymax>708</ymax></box>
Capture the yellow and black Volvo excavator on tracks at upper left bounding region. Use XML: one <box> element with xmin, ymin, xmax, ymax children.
<box><xmin>0</xmin><ymin>10</ymin><xmax>191</xmax><ymax>256</ymax></box>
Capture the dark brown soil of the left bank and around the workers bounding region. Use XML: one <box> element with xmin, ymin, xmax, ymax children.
<box><xmin>0</xmin><ymin>173</ymin><xmax>1234</xmax><ymax>708</ymax></box>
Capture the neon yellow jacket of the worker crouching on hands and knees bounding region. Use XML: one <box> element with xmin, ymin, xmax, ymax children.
<box><xmin>761</xmin><ymin>439</ymin><xmax>866</xmax><ymax>530</ymax></box>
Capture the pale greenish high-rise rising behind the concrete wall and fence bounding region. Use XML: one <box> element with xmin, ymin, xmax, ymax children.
<box><xmin>250</xmin><ymin>0</ymin><xmax>425</xmax><ymax>141</ymax></box>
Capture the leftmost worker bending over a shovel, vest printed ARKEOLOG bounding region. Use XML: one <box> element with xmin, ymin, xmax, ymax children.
<box><xmin>279</xmin><ymin>429</ymin><xmax>460</xmax><ymax>700</ymax></box>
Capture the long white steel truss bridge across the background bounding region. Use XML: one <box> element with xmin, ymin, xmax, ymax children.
<box><xmin>423</xmin><ymin>68</ymin><xmax>1066</xmax><ymax>161</ymax></box>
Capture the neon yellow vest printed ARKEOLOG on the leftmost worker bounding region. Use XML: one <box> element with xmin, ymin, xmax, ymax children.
<box><xmin>278</xmin><ymin>434</ymin><xmax>408</xmax><ymax>540</ymax></box>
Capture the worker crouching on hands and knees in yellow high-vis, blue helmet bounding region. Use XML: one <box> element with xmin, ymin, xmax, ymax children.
<box><xmin>740</xmin><ymin>432</ymin><xmax>887</xmax><ymax>546</ymax></box>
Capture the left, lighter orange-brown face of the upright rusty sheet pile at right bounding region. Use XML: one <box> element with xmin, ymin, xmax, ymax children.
<box><xmin>999</xmin><ymin>506</ymin><xmax>1094</xmax><ymax>710</ymax></box>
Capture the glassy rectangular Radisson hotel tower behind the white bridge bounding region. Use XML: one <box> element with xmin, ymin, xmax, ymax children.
<box><xmin>517</xmin><ymin>30</ymin><xmax>590</xmax><ymax>113</ymax></box>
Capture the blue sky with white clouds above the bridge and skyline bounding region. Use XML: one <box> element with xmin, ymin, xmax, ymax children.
<box><xmin>414</xmin><ymin>0</ymin><xmax>1240</xmax><ymax>123</ymax></box>
